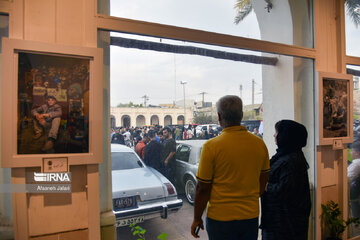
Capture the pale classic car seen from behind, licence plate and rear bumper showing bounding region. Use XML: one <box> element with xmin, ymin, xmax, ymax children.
<box><xmin>111</xmin><ymin>144</ymin><xmax>182</xmax><ymax>227</ymax></box>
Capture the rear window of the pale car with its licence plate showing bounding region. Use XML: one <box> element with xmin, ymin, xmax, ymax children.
<box><xmin>111</xmin><ymin>152</ymin><xmax>143</xmax><ymax>170</ymax></box>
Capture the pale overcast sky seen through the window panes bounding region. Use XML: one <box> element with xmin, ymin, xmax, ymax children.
<box><xmin>111</xmin><ymin>0</ymin><xmax>360</xmax><ymax>106</ymax></box>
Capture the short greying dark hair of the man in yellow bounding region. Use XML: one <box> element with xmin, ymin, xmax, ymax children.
<box><xmin>216</xmin><ymin>95</ymin><xmax>243</xmax><ymax>124</ymax></box>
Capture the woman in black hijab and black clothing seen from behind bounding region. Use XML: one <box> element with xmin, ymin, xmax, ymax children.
<box><xmin>260</xmin><ymin>120</ymin><xmax>311</xmax><ymax>240</ymax></box>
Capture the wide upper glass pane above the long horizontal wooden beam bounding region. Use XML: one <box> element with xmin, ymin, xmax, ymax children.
<box><xmin>110</xmin><ymin>0</ymin><xmax>313</xmax><ymax>48</ymax></box>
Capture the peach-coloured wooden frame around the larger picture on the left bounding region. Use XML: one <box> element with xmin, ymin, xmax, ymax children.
<box><xmin>1</xmin><ymin>38</ymin><xmax>103</xmax><ymax>168</ymax></box>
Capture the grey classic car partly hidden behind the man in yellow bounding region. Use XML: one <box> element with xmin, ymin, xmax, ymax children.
<box><xmin>175</xmin><ymin>139</ymin><xmax>206</xmax><ymax>204</ymax></box>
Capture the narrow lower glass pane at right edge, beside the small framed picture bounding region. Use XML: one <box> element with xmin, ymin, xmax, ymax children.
<box><xmin>346</xmin><ymin>65</ymin><xmax>360</xmax><ymax>238</ymax></box>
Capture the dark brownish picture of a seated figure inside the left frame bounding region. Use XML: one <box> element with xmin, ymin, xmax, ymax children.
<box><xmin>17</xmin><ymin>53</ymin><xmax>90</xmax><ymax>154</ymax></box>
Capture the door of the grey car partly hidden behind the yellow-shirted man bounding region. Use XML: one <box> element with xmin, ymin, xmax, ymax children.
<box><xmin>175</xmin><ymin>144</ymin><xmax>191</xmax><ymax>184</ymax></box>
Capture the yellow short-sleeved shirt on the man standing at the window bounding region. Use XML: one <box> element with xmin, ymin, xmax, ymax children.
<box><xmin>196</xmin><ymin>126</ymin><xmax>270</xmax><ymax>221</ymax></box>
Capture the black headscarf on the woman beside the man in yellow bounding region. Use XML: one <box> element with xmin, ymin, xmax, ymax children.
<box><xmin>274</xmin><ymin>120</ymin><xmax>308</xmax><ymax>157</ymax></box>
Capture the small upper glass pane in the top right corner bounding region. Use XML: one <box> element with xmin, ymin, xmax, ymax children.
<box><xmin>345</xmin><ymin>1</ymin><xmax>360</xmax><ymax>57</ymax></box>
